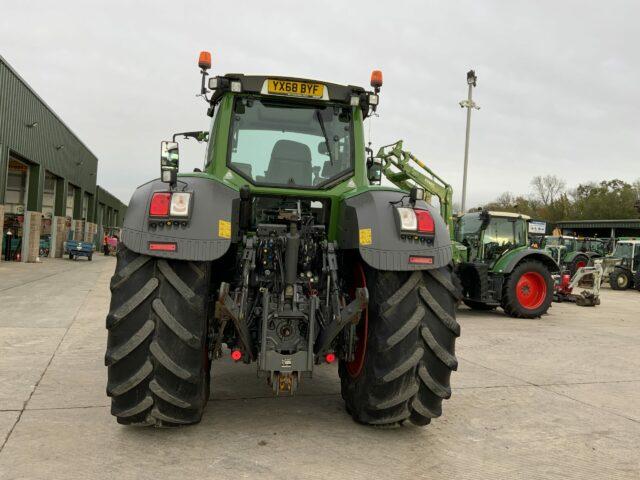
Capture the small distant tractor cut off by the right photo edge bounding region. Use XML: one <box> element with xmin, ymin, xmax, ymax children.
<box><xmin>601</xmin><ymin>237</ymin><xmax>640</xmax><ymax>291</ymax></box>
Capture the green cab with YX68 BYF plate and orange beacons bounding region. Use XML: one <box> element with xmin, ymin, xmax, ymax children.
<box><xmin>161</xmin><ymin>52</ymin><xmax>390</xmax><ymax>244</ymax></box>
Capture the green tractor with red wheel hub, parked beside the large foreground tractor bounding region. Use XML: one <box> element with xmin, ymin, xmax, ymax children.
<box><xmin>456</xmin><ymin>210</ymin><xmax>558</xmax><ymax>318</ymax></box>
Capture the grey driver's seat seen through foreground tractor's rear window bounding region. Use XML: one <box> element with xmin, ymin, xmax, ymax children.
<box><xmin>265</xmin><ymin>140</ymin><xmax>312</xmax><ymax>186</ymax></box>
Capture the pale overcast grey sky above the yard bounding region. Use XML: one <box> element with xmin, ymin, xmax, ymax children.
<box><xmin>0</xmin><ymin>0</ymin><xmax>640</xmax><ymax>206</ymax></box>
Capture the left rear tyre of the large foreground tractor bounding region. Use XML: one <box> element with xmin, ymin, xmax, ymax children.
<box><xmin>105</xmin><ymin>245</ymin><xmax>210</xmax><ymax>426</ymax></box>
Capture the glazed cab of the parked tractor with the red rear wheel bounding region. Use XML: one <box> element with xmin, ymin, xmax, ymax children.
<box><xmin>456</xmin><ymin>210</ymin><xmax>530</xmax><ymax>264</ymax></box>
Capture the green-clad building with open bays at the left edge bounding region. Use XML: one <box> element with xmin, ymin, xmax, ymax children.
<box><xmin>0</xmin><ymin>56</ymin><xmax>126</xmax><ymax>262</ymax></box>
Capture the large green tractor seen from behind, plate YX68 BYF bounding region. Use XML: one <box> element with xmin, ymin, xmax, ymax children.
<box><xmin>105</xmin><ymin>52</ymin><xmax>460</xmax><ymax>426</ymax></box>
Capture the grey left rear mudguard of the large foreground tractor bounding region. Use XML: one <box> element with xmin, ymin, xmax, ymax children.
<box><xmin>120</xmin><ymin>177</ymin><xmax>240</xmax><ymax>261</ymax></box>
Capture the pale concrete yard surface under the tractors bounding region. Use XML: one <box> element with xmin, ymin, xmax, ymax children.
<box><xmin>0</xmin><ymin>255</ymin><xmax>640</xmax><ymax>480</ymax></box>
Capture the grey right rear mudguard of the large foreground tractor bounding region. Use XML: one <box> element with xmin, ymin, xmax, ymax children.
<box><xmin>338</xmin><ymin>190</ymin><xmax>452</xmax><ymax>271</ymax></box>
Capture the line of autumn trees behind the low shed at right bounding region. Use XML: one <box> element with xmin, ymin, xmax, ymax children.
<box><xmin>484</xmin><ymin>175</ymin><xmax>640</xmax><ymax>223</ymax></box>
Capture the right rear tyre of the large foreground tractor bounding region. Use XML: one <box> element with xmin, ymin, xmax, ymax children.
<box><xmin>339</xmin><ymin>267</ymin><xmax>461</xmax><ymax>425</ymax></box>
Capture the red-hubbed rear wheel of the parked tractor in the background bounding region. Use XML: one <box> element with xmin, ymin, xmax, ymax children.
<box><xmin>502</xmin><ymin>260</ymin><xmax>553</xmax><ymax>318</ymax></box>
